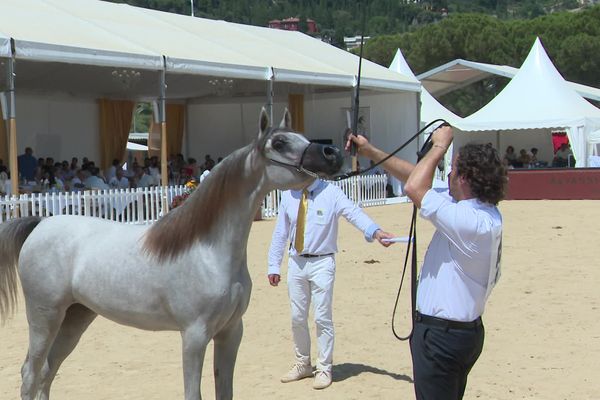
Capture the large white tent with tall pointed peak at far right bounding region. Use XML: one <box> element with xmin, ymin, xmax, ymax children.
<box><xmin>457</xmin><ymin>38</ymin><xmax>600</xmax><ymax>167</ymax></box>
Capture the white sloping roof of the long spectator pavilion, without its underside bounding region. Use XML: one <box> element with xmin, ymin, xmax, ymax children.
<box><xmin>0</xmin><ymin>0</ymin><xmax>419</xmax><ymax>91</ymax></box>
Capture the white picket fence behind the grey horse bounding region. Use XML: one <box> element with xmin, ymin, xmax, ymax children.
<box><xmin>0</xmin><ymin>175</ymin><xmax>387</xmax><ymax>224</ymax></box>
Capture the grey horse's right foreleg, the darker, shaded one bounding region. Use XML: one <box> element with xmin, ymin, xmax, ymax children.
<box><xmin>214</xmin><ymin>318</ymin><xmax>244</xmax><ymax>400</ymax></box>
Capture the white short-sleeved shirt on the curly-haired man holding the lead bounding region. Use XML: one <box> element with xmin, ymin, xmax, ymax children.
<box><xmin>417</xmin><ymin>189</ymin><xmax>502</xmax><ymax>321</ymax></box>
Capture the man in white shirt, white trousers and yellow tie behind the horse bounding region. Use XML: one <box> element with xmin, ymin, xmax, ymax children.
<box><xmin>268</xmin><ymin>180</ymin><xmax>393</xmax><ymax>389</ymax></box>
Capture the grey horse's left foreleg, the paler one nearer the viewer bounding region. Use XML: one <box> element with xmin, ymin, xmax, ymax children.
<box><xmin>181</xmin><ymin>323</ymin><xmax>211</xmax><ymax>400</ymax></box>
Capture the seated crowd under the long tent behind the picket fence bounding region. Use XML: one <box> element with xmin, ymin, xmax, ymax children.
<box><xmin>0</xmin><ymin>147</ymin><xmax>221</xmax><ymax>195</ymax></box>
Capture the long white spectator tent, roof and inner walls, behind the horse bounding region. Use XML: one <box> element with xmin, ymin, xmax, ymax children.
<box><xmin>0</xmin><ymin>0</ymin><xmax>420</xmax><ymax>179</ymax></box>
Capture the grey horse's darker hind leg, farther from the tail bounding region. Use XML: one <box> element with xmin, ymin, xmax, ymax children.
<box><xmin>39</xmin><ymin>304</ymin><xmax>98</xmax><ymax>400</ymax></box>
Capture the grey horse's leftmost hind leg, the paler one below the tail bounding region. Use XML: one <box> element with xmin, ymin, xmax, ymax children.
<box><xmin>21</xmin><ymin>303</ymin><xmax>65</xmax><ymax>400</ymax></box>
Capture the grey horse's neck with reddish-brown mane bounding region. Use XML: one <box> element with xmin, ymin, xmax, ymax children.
<box><xmin>145</xmin><ymin>145</ymin><xmax>269</xmax><ymax>259</ymax></box>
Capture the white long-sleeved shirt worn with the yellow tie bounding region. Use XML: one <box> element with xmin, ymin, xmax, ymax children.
<box><xmin>268</xmin><ymin>180</ymin><xmax>380</xmax><ymax>274</ymax></box>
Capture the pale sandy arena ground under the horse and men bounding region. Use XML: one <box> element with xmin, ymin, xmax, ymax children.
<box><xmin>0</xmin><ymin>201</ymin><xmax>600</xmax><ymax>400</ymax></box>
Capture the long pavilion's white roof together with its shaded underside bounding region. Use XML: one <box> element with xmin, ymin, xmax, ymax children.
<box><xmin>0</xmin><ymin>0</ymin><xmax>419</xmax><ymax>98</ymax></box>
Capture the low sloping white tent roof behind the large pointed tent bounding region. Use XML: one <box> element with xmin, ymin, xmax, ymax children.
<box><xmin>417</xmin><ymin>58</ymin><xmax>600</xmax><ymax>101</ymax></box>
